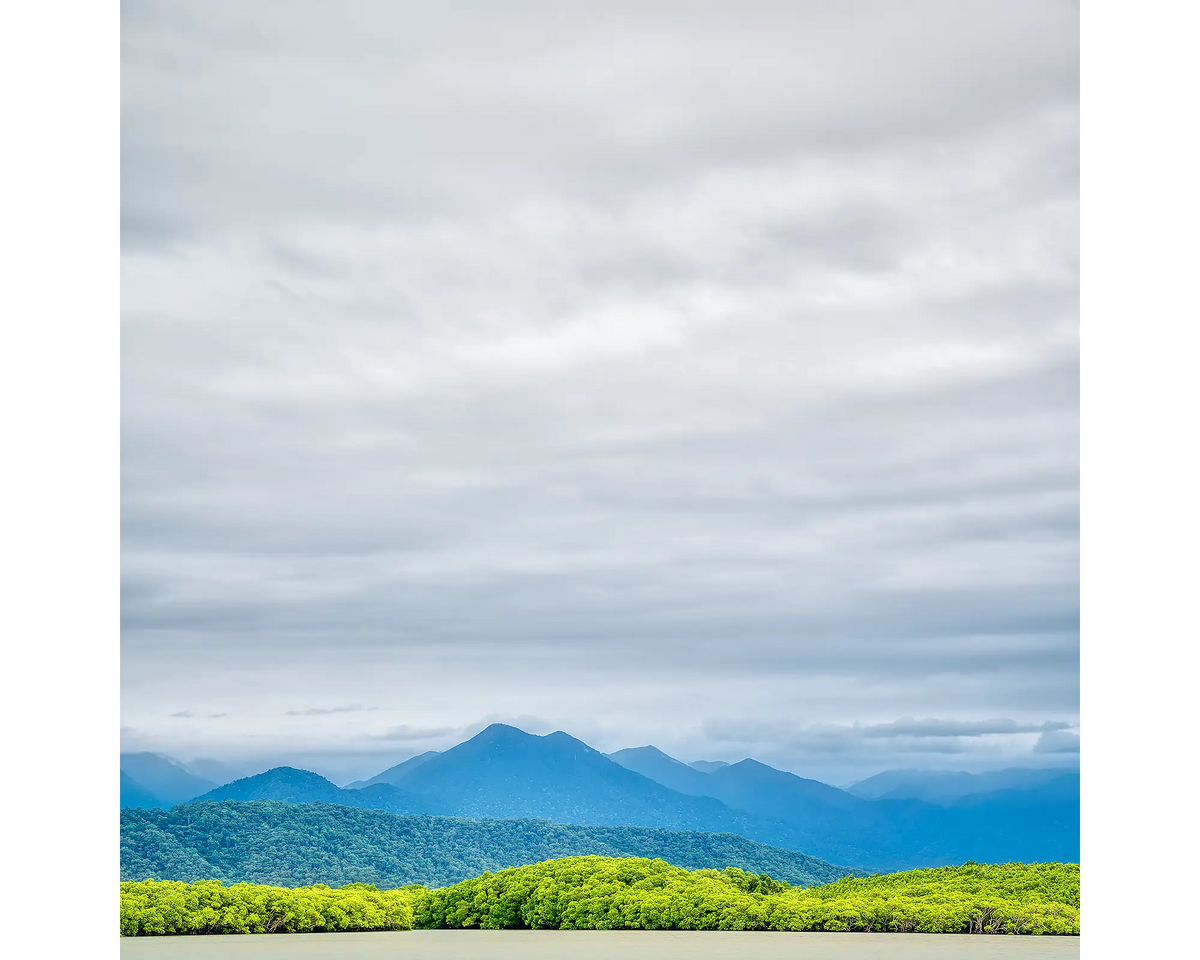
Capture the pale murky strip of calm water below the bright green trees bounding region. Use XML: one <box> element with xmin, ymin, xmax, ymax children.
<box><xmin>116</xmin><ymin>930</ymin><xmax>1084</xmax><ymax>960</ymax></box>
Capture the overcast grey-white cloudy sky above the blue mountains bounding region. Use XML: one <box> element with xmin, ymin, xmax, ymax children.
<box><xmin>116</xmin><ymin>0</ymin><xmax>1082</xmax><ymax>782</ymax></box>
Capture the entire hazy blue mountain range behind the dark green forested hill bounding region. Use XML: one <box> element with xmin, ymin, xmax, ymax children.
<box><xmin>118</xmin><ymin>724</ymin><xmax>1081</xmax><ymax>870</ymax></box>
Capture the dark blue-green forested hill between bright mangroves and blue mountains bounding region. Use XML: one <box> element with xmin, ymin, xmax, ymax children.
<box><xmin>118</xmin><ymin>800</ymin><xmax>864</xmax><ymax>888</ymax></box>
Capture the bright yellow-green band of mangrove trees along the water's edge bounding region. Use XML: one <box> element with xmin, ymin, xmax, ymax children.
<box><xmin>119</xmin><ymin>857</ymin><xmax>1082</xmax><ymax>936</ymax></box>
